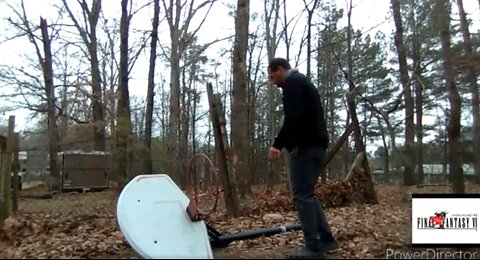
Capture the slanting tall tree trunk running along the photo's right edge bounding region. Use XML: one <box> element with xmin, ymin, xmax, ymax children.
<box><xmin>457</xmin><ymin>0</ymin><xmax>480</xmax><ymax>184</ymax></box>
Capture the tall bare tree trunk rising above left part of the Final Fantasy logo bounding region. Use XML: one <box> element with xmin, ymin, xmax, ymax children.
<box><xmin>391</xmin><ymin>0</ymin><xmax>415</xmax><ymax>185</ymax></box>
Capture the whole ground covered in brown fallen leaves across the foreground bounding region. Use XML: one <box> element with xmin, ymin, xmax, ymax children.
<box><xmin>0</xmin><ymin>182</ymin><xmax>480</xmax><ymax>259</ymax></box>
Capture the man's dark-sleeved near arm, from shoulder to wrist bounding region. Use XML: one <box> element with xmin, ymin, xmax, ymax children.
<box><xmin>272</xmin><ymin>82</ymin><xmax>304</xmax><ymax>150</ymax></box>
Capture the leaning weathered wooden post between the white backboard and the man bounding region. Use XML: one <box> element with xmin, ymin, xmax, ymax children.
<box><xmin>207</xmin><ymin>83</ymin><xmax>240</xmax><ymax>217</ymax></box>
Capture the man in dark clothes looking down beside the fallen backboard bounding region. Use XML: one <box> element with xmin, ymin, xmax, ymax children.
<box><xmin>268</xmin><ymin>58</ymin><xmax>338</xmax><ymax>258</ymax></box>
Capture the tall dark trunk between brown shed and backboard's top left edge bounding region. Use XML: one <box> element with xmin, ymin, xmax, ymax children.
<box><xmin>116</xmin><ymin>0</ymin><xmax>132</xmax><ymax>181</ymax></box>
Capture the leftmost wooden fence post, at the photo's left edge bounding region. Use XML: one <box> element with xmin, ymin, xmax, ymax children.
<box><xmin>0</xmin><ymin>116</ymin><xmax>15</xmax><ymax>220</ymax></box>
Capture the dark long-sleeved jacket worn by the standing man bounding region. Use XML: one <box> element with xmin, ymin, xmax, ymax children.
<box><xmin>272</xmin><ymin>70</ymin><xmax>329</xmax><ymax>151</ymax></box>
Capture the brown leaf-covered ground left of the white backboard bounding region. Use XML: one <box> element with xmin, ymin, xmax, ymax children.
<box><xmin>0</xmin><ymin>189</ymin><xmax>139</xmax><ymax>259</ymax></box>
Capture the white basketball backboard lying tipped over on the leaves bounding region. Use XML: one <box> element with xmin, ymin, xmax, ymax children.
<box><xmin>117</xmin><ymin>174</ymin><xmax>214</xmax><ymax>259</ymax></box>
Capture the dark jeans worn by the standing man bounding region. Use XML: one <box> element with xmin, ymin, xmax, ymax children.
<box><xmin>289</xmin><ymin>147</ymin><xmax>335</xmax><ymax>251</ymax></box>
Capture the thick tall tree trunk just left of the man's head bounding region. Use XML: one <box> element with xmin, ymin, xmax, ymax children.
<box><xmin>231</xmin><ymin>0</ymin><xmax>251</xmax><ymax>196</ymax></box>
